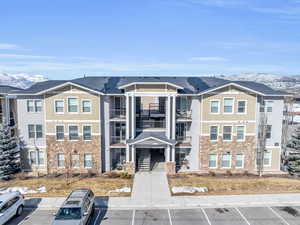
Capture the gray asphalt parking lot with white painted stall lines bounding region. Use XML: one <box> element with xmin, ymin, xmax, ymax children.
<box><xmin>7</xmin><ymin>206</ymin><xmax>300</xmax><ymax>225</ymax></box>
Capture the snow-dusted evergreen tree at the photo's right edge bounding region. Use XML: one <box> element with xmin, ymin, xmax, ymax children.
<box><xmin>287</xmin><ymin>127</ymin><xmax>300</xmax><ymax>174</ymax></box>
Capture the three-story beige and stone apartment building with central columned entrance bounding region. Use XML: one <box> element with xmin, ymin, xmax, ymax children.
<box><xmin>13</xmin><ymin>77</ymin><xmax>286</xmax><ymax>174</ymax></box>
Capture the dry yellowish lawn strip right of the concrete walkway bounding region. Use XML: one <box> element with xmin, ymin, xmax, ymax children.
<box><xmin>168</xmin><ymin>174</ymin><xmax>300</xmax><ymax>195</ymax></box>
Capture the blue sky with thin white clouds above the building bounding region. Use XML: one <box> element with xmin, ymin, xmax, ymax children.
<box><xmin>0</xmin><ymin>0</ymin><xmax>300</xmax><ymax>79</ymax></box>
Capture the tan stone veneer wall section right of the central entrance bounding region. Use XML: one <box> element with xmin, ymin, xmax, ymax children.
<box><xmin>199</xmin><ymin>136</ymin><xmax>256</xmax><ymax>173</ymax></box>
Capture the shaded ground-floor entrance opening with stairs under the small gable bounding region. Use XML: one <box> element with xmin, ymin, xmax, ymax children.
<box><xmin>136</xmin><ymin>148</ymin><xmax>165</xmax><ymax>171</ymax></box>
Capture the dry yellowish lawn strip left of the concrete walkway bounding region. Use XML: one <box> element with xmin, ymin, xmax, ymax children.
<box><xmin>0</xmin><ymin>177</ymin><xmax>133</xmax><ymax>197</ymax></box>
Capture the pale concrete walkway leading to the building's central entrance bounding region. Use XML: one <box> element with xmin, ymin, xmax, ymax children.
<box><xmin>131</xmin><ymin>171</ymin><xmax>172</xmax><ymax>207</ymax></box>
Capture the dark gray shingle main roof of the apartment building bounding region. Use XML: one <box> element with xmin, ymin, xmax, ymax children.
<box><xmin>11</xmin><ymin>76</ymin><xmax>287</xmax><ymax>95</ymax></box>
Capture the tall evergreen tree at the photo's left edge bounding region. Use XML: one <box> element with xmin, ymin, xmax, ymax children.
<box><xmin>0</xmin><ymin>125</ymin><xmax>21</xmax><ymax>180</ymax></box>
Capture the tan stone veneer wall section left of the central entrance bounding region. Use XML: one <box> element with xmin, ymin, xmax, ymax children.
<box><xmin>46</xmin><ymin>136</ymin><xmax>101</xmax><ymax>174</ymax></box>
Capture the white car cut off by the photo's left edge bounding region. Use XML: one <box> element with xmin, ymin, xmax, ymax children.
<box><xmin>0</xmin><ymin>192</ymin><xmax>24</xmax><ymax>225</ymax></box>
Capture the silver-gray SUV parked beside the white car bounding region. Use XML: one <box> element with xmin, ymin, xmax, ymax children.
<box><xmin>52</xmin><ymin>189</ymin><xmax>95</xmax><ymax>225</ymax></box>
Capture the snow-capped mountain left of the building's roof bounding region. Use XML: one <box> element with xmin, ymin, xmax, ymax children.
<box><xmin>0</xmin><ymin>72</ymin><xmax>47</xmax><ymax>88</ymax></box>
